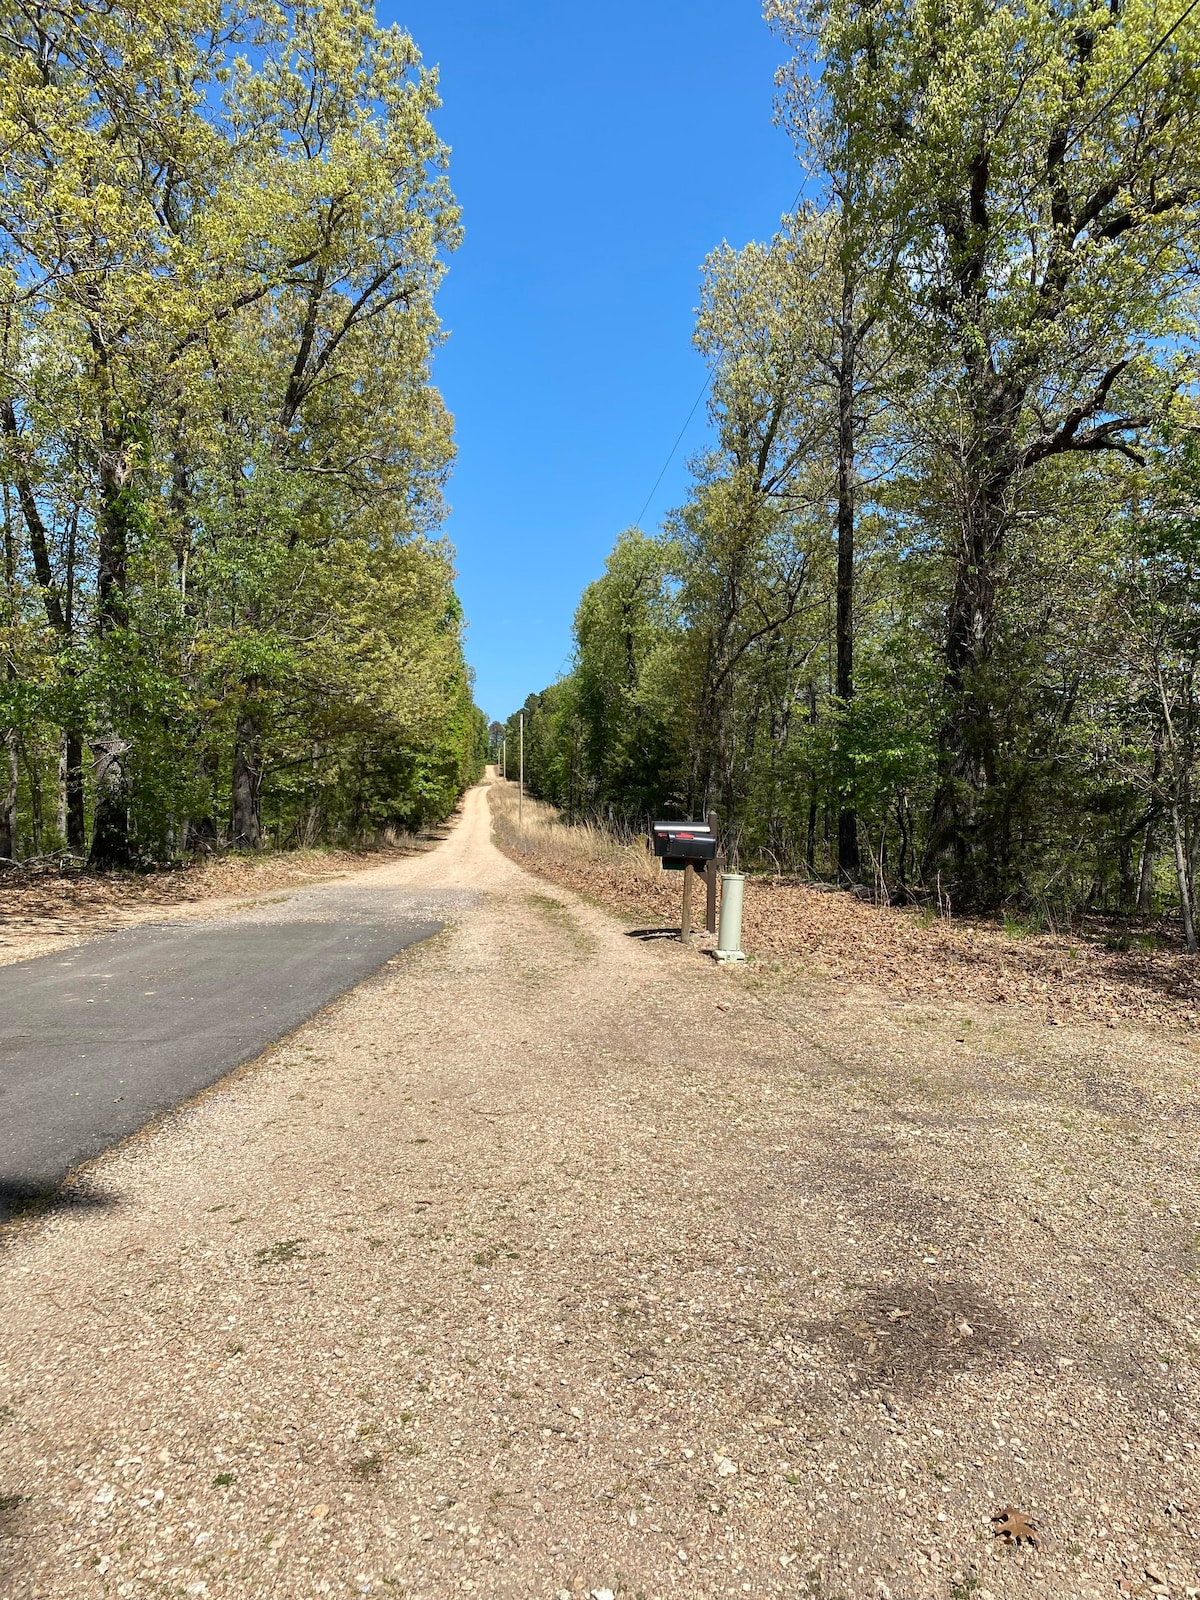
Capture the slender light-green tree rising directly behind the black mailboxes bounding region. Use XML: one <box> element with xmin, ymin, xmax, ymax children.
<box><xmin>684</xmin><ymin>228</ymin><xmax>830</xmax><ymax>840</ymax></box>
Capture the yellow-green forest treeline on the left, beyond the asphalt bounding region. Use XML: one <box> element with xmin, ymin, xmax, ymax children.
<box><xmin>0</xmin><ymin>0</ymin><xmax>486</xmax><ymax>866</ymax></box>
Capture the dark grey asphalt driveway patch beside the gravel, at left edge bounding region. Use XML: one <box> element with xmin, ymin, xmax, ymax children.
<box><xmin>0</xmin><ymin>888</ymin><xmax>454</xmax><ymax>1219</ymax></box>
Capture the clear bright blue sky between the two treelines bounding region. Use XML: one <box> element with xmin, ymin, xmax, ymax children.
<box><xmin>378</xmin><ymin>0</ymin><xmax>800</xmax><ymax>717</ymax></box>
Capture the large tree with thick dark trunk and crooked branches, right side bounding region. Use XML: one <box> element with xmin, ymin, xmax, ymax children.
<box><xmin>778</xmin><ymin>0</ymin><xmax>1200</xmax><ymax>890</ymax></box>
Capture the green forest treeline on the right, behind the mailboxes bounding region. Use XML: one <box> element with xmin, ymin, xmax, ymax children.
<box><xmin>507</xmin><ymin>0</ymin><xmax>1200</xmax><ymax>946</ymax></box>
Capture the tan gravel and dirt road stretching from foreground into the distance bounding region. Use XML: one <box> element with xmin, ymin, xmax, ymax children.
<box><xmin>0</xmin><ymin>789</ymin><xmax>1200</xmax><ymax>1600</ymax></box>
